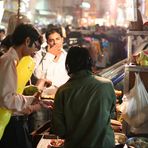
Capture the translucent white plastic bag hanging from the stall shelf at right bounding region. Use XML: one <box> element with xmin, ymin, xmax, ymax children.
<box><xmin>120</xmin><ymin>73</ymin><xmax>148</xmax><ymax>128</ymax></box>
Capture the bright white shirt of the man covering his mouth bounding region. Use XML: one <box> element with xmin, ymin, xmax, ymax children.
<box><xmin>34</xmin><ymin>49</ymin><xmax>69</xmax><ymax>87</ymax></box>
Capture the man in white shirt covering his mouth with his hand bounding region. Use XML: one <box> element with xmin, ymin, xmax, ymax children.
<box><xmin>34</xmin><ymin>26</ymin><xmax>69</xmax><ymax>87</ymax></box>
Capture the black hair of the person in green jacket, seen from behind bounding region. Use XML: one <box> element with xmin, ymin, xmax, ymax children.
<box><xmin>65</xmin><ymin>46</ymin><xmax>92</xmax><ymax>75</ymax></box>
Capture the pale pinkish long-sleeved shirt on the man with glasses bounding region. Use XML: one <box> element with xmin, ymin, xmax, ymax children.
<box><xmin>0</xmin><ymin>48</ymin><xmax>34</xmax><ymax>114</ymax></box>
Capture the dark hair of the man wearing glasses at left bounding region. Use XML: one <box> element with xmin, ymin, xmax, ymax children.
<box><xmin>12</xmin><ymin>24</ymin><xmax>42</xmax><ymax>46</ymax></box>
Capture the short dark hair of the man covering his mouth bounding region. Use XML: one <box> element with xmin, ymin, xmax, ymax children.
<box><xmin>45</xmin><ymin>25</ymin><xmax>63</xmax><ymax>40</ymax></box>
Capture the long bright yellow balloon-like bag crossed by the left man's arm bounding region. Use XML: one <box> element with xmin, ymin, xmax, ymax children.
<box><xmin>0</xmin><ymin>56</ymin><xmax>35</xmax><ymax>140</ymax></box>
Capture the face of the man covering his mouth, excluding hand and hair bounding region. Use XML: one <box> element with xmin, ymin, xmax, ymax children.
<box><xmin>47</xmin><ymin>32</ymin><xmax>63</xmax><ymax>49</ymax></box>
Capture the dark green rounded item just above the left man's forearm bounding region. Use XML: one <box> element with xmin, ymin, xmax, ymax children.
<box><xmin>23</xmin><ymin>85</ymin><xmax>39</xmax><ymax>96</ymax></box>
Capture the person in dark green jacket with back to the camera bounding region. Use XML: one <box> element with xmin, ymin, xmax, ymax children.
<box><xmin>51</xmin><ymin>46</ymin><xmax>116</xmax><ymax>148</ymax></box>
